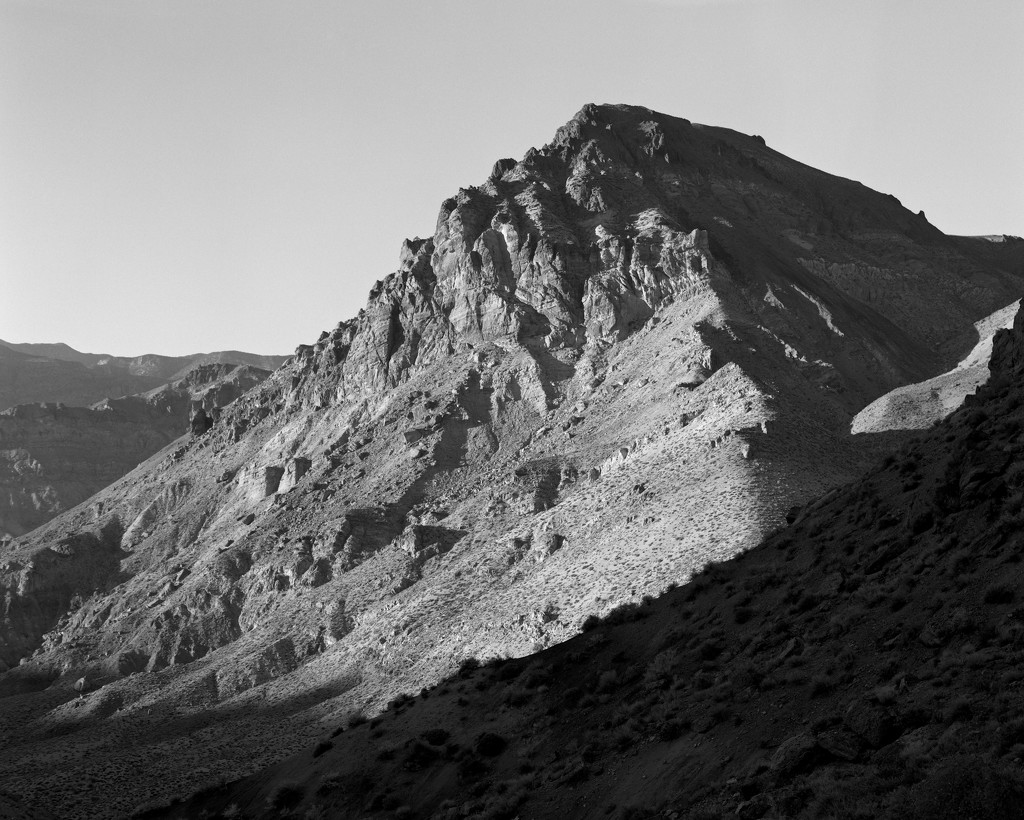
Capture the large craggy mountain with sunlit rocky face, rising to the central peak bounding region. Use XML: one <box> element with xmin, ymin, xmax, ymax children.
<box><xmin>0</xmin><ymin>105</ymin><xmax>1024</xmax><ymax>817</ymax></box>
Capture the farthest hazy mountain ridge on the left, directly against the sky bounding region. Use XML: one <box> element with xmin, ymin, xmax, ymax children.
<box><xmin>0</xmin><ymin>340</ymin><xmax>286</xmax><ymax>409</ymax></box>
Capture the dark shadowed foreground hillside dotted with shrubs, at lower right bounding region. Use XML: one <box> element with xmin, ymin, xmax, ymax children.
<box><xmin>153</xmin><ymin>300</ymin><xmax>1024</xmax><ymax>820</ymax></box>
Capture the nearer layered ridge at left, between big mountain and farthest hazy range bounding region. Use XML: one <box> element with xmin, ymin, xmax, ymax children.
<box><xmin>0</xmin><ymin>363</ymin><xmax>269</xmax><ymax>538</ymax></box>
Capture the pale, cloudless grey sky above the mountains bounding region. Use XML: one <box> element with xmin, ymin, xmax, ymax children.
<box><xmin>0</xmin><ymin>0</ymin><xmax>1024</xmax><ymax>355</ymax></box>
